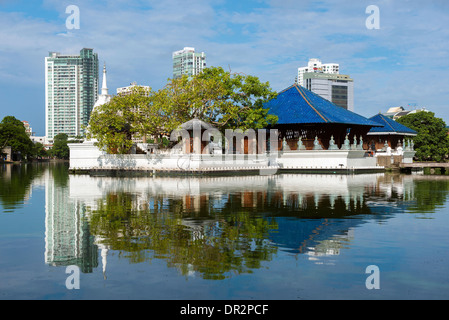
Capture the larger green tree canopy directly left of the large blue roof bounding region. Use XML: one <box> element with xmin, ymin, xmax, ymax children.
<box><xmin>154</xmin><ymin>67</ymin><xmax>277</xmax><ymax>130</ymax></box>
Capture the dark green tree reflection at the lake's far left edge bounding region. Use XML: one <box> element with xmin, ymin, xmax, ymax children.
<box><xmin>0</xmin><ymin>164</ymin><xmax>44</xmax><ymax>210</ymax></box>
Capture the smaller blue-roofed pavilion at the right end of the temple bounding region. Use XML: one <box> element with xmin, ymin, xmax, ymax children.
<box><xmin>366</xmin><ymin>113</ymin><xmax>417</xmax><ymax>150</ymax></box>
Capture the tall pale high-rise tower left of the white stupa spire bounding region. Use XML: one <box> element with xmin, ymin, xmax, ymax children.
<box><xmin>45</xmin><ymin>48</ymin><xmax>99</xmax><ymax>140</ymax></box>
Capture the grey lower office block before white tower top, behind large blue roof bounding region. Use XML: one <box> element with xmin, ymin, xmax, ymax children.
<box><xmin>303</xmin><ymin>72</ymin><xmax>354</xmax><ymax>111</ymax></box>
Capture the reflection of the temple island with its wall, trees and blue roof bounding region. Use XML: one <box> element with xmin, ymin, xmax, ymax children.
<box><xmin>61</xmin><ymin>174</ymin><xmax>422</xmax><ymax>276</ymax></box>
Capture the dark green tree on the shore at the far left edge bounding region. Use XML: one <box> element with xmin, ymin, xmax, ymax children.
<box><xmin>0</xmin><ymin>116</ymin><xmax>33</xmax><ymax>158</ymax></box>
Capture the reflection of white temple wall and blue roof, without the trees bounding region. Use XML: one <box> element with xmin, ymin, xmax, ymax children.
<box><xmin>69</xmin><ymin>174</ymin><xmax>413</xmax><ymax>273</ymax></box>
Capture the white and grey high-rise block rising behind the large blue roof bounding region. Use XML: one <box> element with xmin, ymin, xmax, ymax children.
<box><xmin>296</xmin><ymin>59</ymin><xmax>354</xmax><ymax>111</ymax></box>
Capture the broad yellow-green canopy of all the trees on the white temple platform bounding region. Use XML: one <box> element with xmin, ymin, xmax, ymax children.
<box><xmin>88</xmin><ymin>67</ymin><xmax>277</xmax><ymax>153</ymax></box>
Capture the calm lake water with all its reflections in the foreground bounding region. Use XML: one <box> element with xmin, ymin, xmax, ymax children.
<box><xmin>0</xmin><ymin>164</ymin><xmax>449</xmax><ymax>300</ymax></box>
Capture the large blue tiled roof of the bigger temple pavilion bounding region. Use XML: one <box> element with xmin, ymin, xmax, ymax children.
<box><xmin>265</xmin><ymin>84</ymin><xmax>380</xmax><ymax>127</ymax></box>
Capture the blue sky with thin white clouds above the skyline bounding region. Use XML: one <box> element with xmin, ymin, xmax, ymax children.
<box><xmin>0</xmin><ymin>0</ymin><xmax>449</xmax><ymax>135</ymax></box>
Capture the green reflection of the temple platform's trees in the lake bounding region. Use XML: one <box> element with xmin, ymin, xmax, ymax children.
<box><xmin>91</xmin><ymin>192</ymin><xmax>277</xmax><ymax>279</ymax></box>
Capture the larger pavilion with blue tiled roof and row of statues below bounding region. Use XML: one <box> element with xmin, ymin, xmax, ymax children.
<box><xmin>265</xmin><ymin>84</ymin><xmax>381</xmax><ymax>150</ymax></box>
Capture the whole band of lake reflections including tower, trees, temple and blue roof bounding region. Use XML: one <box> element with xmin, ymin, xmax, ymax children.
<box><xmin>0</xmin><ymin>166</ymin><xmax>449</xmax><ymax>279</ymax></box>
